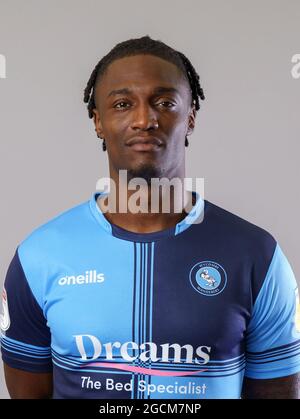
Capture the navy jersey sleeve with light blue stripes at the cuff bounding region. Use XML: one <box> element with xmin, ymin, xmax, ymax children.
<box><xmin>0</xmin><ymin>249</ymin><xmax>52</xmax><ymax>372</ymax></box>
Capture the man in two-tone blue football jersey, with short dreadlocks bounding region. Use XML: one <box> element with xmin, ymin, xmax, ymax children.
<box><xmin>2</xmin><ymin>36</ymin><xmax>300</xmax><ymax>399</ymax></box>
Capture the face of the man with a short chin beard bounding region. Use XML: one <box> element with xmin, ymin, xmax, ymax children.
<box><xmin>94</xmin><ymin>55</ymin><xmax>196</xmax><ymax>180</ymax></box>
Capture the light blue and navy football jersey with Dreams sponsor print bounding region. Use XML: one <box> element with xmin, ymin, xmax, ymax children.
<box><xmin>1</xmin><ymin>191</ymin><xmax>300</xmax><ymax>399</ymax></box>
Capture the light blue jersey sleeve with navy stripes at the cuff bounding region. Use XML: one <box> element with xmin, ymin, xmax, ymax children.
<box><xmin>245</xmin><ymin>243</ymin><xmax>300</xmax><ymax>379</ymax></box>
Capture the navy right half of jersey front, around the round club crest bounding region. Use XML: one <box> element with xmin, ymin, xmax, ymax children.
<box><xmin>153</xmin><ymin>201</ymin><xmax>275</xmax><ymax>359</ymax></box>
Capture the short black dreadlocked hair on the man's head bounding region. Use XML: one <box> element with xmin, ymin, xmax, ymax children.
<box><xmin>83</xmin><ymin>35</ymin><xmax>205</xmax><ymax>151</ymax></box>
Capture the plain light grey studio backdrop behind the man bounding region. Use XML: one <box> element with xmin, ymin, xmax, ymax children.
<box><xmin>0</xmin><ymin>0</ymin><xmax>300</xmax><ymax>398</ymax></box>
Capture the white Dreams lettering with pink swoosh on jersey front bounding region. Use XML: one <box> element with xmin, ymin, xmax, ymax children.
<box><xmin>74</xmin><ymin>335</ymin><xmax>211</xmax><ymax>376</ymax></box>
